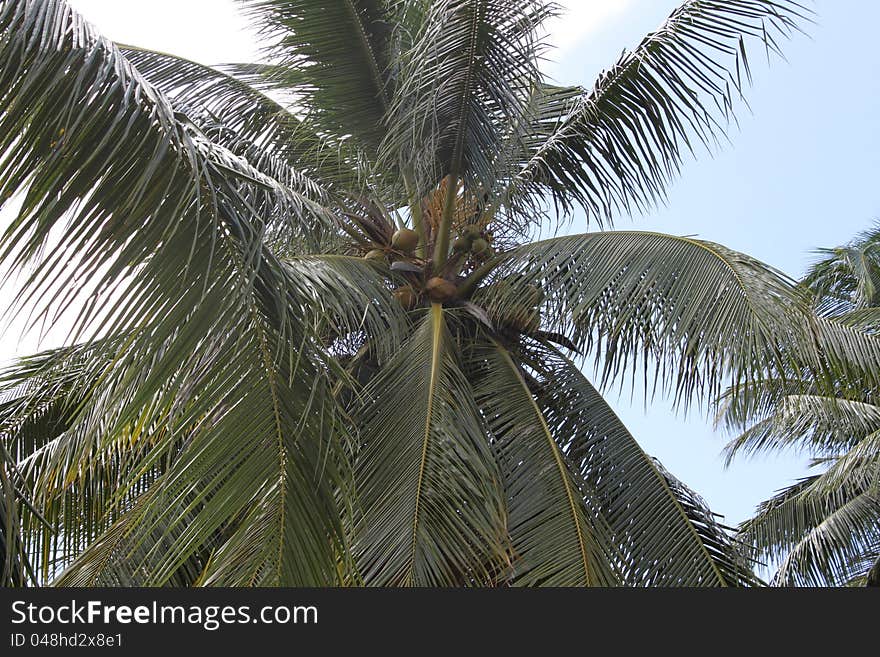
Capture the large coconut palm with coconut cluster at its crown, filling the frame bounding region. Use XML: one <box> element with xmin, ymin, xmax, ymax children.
<box><xmin>0</xmin><ymin>0</ymin><xmax>868</xmax><ymax>586</ymax></box>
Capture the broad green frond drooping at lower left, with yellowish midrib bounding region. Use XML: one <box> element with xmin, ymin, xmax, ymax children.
<box><xmin>46</xmin><ymin>307</ymin><xmax>345</xmax><ymax>586</ymax></box>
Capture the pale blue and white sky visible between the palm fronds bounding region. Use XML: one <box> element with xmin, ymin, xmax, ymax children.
<box><xmin>0</xmin><ymin>0</ymin><xmax>880</xmax><ymax>524</ymax></box>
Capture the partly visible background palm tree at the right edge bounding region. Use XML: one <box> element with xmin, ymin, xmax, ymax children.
<box><xmin>725</xmin><ymin>227</ymin><xmax>880</xmax><ymax>586</ymax></box>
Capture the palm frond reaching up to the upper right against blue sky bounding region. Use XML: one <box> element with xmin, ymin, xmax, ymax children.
<box><xmin>492</xmin><ymin>0</ymin><xmax>809</xmax><ymax>224</ymax></box>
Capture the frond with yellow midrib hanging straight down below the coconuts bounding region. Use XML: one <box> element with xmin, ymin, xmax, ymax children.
<box><xmin>355</xmin><ymin>304</ymin><xmax>509</xmax><ymax>586</ymax></box>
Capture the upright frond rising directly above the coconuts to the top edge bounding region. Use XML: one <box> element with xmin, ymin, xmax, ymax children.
<box><xmin>383</xmin><ymin>0</ymin><xmax>555</xmax><ymax>194</ymax></box>
